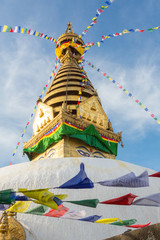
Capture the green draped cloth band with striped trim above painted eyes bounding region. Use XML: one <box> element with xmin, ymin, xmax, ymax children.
<box><xmin>23</xmin><ymin>121</ymin><xmax>118</xmax><ymax>156</ymax></box>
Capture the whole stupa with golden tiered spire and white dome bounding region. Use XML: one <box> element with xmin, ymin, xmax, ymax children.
<box><xmin>0</xmin><ymin>23</ymin><xmax>159</xmax><ymax>240</ymax></box>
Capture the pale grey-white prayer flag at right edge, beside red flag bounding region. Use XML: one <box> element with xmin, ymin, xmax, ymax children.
<box><xmin>133</xmin><ymin>193</ymin><xmax>160</xmax><ymax>207</ymax></box>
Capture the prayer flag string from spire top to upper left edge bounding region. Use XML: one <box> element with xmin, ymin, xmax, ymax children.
<box><xmin>0</xmin><ymin>25</ymin><xmax>57</xmax><ymax>43</ymax></box>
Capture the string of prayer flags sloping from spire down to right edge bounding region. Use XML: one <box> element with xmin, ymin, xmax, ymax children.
<box><xmin>83</xmin><ymin>59</ymin><xmax>160</xmax><ymax>124</ymax></box>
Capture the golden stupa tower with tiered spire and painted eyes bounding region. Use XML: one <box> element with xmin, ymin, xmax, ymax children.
<box><xmin>23</xmin><ymin>22</ymin><xmax>121</xmax><ymax>160</ymax></box>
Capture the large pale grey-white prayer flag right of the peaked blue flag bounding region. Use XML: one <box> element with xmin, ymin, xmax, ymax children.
<box><xmin>98</xmin><ymin>171</ymin><xmax>149</xmax><ymax>187</ymax></box>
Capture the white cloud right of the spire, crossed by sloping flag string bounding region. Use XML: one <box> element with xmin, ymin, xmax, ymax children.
<box><xmin>87</xmin><ymin>51</ymin><xmax>160</xmax><ymax>137</ymax></box>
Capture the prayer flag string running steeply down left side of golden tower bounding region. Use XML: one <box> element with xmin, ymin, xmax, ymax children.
<box><xmin>10</xmin><ymin>57</ymin><xmax>59</xmax><ymax>165</ymax></box>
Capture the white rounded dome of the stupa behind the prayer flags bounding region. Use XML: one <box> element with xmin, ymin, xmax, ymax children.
<box><xmin>0</xmin><ymin>157</ymin><xmax>160</xmax><ymax>240</ymax></box>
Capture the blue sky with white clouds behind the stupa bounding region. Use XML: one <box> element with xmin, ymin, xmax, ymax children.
<box><xmin>0</xmin><ymin>0</ymin><xmax>160</xmax><ymax>171</ymax></box>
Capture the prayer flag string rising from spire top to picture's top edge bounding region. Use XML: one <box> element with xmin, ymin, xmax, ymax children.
<box><xmin>79</xmin><ymin>0</ymin><xmax>114</xmax><ymax>37</ymax></box>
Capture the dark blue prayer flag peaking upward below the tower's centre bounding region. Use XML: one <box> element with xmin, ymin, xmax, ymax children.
<box><xmin>59</xmin><ymin>163</ymin><xmax>94</xmax><ymax>189</ymax></box>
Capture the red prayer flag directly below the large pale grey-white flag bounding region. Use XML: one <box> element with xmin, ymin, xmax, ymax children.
<box><xmin>100</xmin><ymin>193</ymin><xmax>138</xmax><ymax>205</ymax></box>
